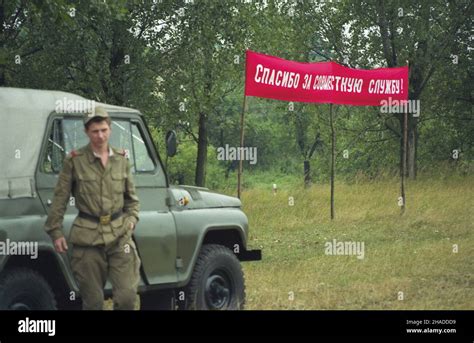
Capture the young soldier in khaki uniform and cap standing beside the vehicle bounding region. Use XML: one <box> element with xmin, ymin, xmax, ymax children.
<box><xmin>45</xmin><ymin>107</ymin><xmax>140</xmax><ymax>310</ymax></box>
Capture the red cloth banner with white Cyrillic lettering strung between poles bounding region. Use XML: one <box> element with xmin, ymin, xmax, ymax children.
<box><xmin>245</xmin><ymin>50</ymin><xmax>408</xmax><ymax>106</ymax></box>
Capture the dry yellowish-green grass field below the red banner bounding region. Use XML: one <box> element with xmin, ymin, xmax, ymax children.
<box><xmin>239</xmin><ymin>175</ymin><xmax>474</xmax><ymax>310</ymax></box>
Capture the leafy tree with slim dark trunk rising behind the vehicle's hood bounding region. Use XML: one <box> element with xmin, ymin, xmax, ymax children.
<box><xmin>154</xmin><ymin>1</ymin><xmax>255</xmax><ymax>186</ymax></box>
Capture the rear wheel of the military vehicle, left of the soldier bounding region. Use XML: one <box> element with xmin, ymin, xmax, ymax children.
<box><xmin>0</xmin><ymin>268</ymin><xmax>56</xmax><ymax>310</ymax></box>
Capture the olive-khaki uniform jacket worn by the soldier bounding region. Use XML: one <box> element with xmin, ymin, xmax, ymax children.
<box><xmin>45</xmin><ymin>144</ymin><xmax>139</xmax><ymax>246</ymax></box>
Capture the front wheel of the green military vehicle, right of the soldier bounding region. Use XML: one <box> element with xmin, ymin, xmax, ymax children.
<box><xmin>185</xmin><ymin>244</ymin><xmax>245</xmax><ymax>310</ymax></box>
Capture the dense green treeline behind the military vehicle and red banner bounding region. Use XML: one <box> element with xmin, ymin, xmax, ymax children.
<box><xmin>0</xmin><ymin>0</ymin><xmax>474</xmax><ymax>186</ymax></box>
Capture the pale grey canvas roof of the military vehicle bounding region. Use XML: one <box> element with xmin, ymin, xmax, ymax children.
<box><xmin>0</xmin><ymin>87</ymin><xmax>139</xmax><ymax>199</ymax></box>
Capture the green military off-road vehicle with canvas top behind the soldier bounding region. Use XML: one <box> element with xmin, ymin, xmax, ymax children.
<box><xmin>0</xmin><ymin>87</ymin><xmax>261</xmax><ymax>310</ymax></box>
